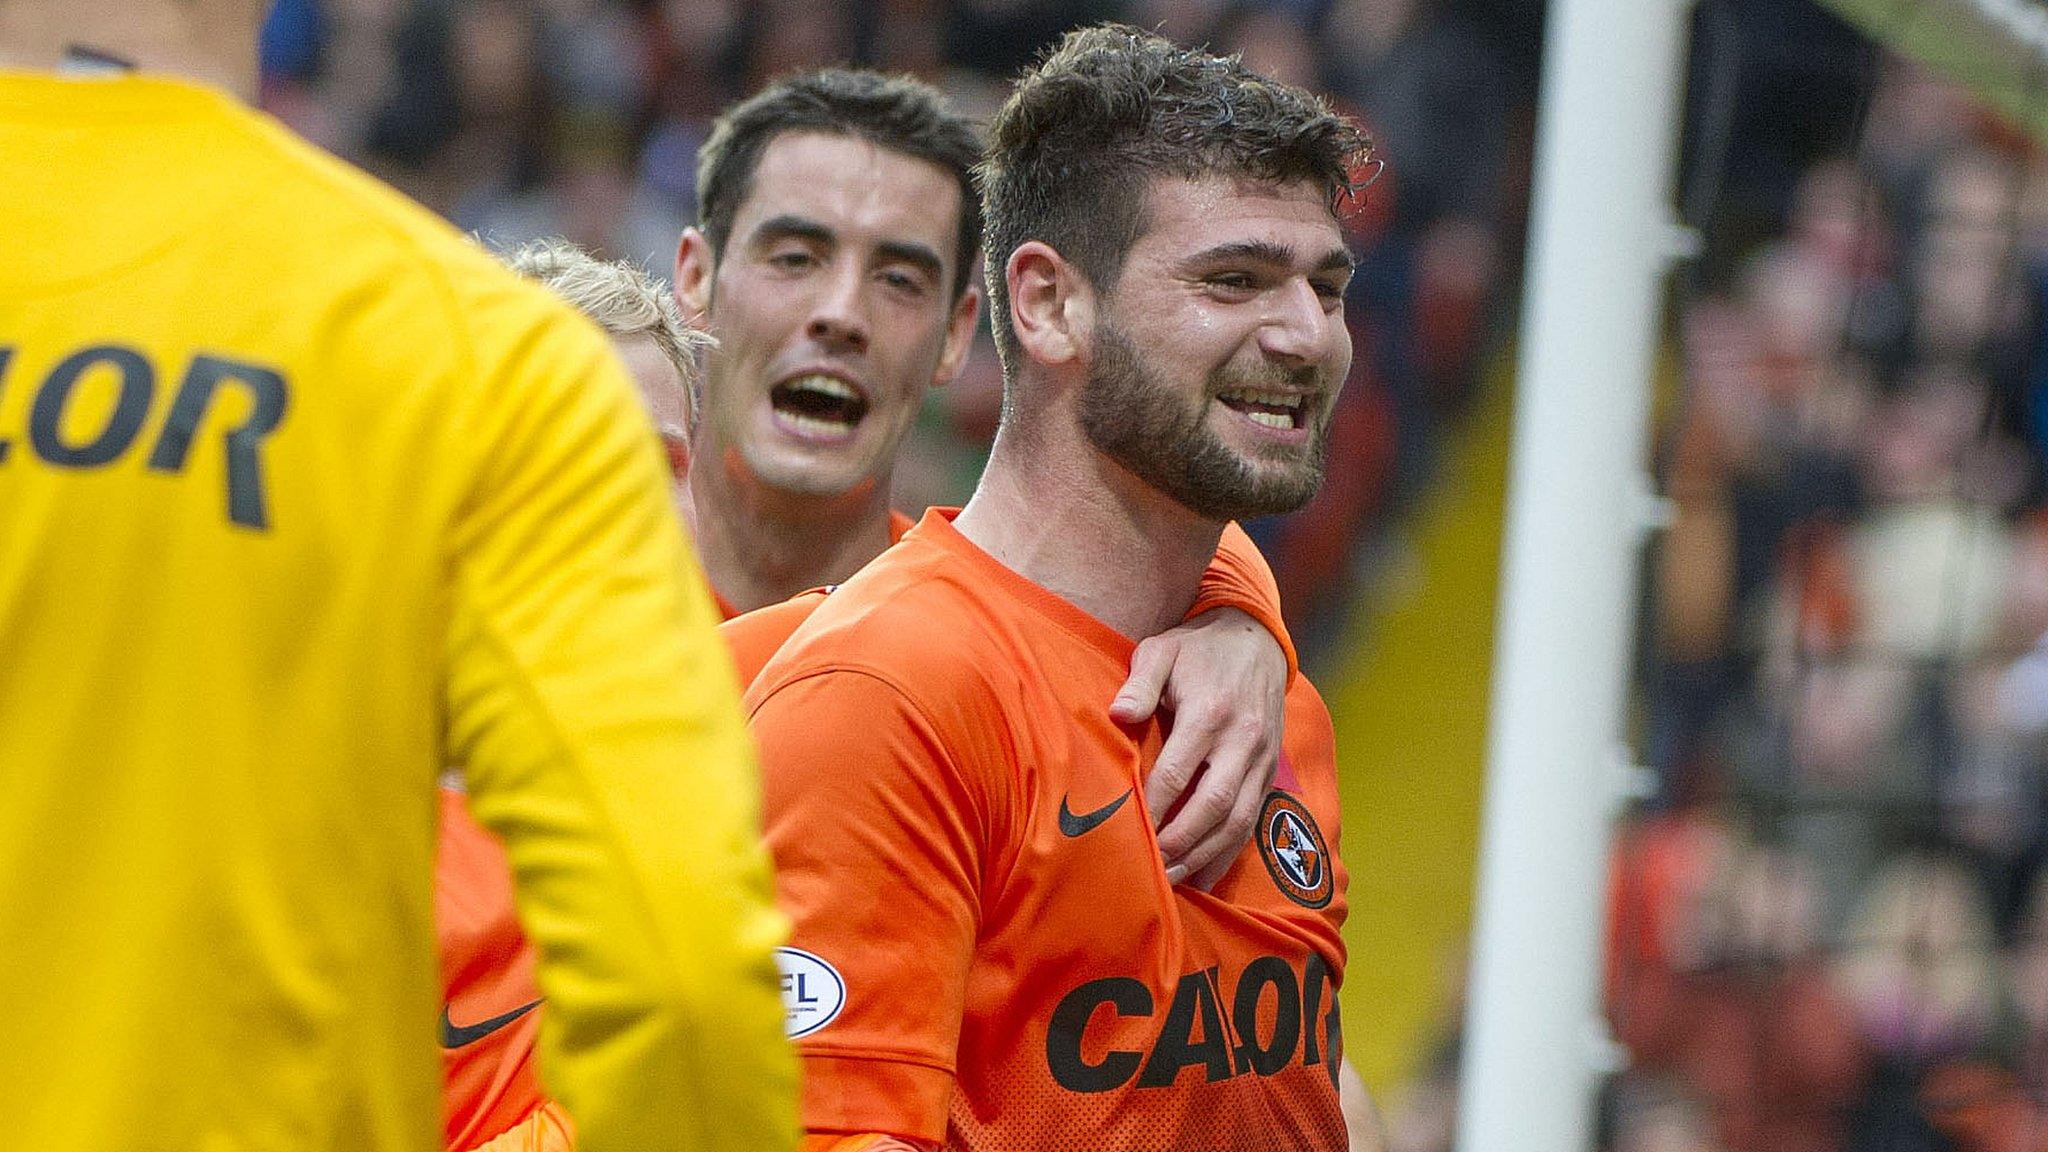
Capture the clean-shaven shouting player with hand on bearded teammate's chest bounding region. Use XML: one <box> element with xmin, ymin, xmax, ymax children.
<box><xmin>676</xmin><ymin>68</ymin><xmax>1292</xmax><ymax>860</ymax></box>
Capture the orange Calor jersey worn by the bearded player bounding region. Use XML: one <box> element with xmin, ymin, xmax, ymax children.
<box><xmin>745</xmin><ymin>510</ymin><xmax>1346</xmax><ymax>1152</ymax></box>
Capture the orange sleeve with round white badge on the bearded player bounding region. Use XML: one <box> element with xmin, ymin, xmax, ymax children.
<box><xmin>752</xmin><ymin>668</ymin><xmax>985</xmax><ymax>1144</ymax></box>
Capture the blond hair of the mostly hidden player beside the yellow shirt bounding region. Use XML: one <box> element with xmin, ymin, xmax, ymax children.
<box><xmin>506</xmin><ymin>236</ymin><xmax>713</xmax><ymax>424</ymax></box>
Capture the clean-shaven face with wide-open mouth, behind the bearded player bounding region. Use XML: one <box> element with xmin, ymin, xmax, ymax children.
<box><xmin>676</xmin><ymin>131</ymin><xmax>979</xmax><ymax>498</ymax></box>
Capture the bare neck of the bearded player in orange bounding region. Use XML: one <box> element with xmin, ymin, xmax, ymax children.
<box><xmin>954</xmin><ymin>420</ymin><xmax>1223</xmax><ymax>640</ymax></box>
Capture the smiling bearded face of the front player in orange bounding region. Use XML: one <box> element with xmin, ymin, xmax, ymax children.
<box><xmin>1079</xmin><ymin>176</ymin><xmax>1352</xmax><ymax>521</ymax></box>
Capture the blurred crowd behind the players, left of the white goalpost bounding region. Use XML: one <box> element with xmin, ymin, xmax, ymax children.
<box><xmin>251</xmin><ymin>0</ymin><xmax>1542</xmax><ymax>664</ymax></box>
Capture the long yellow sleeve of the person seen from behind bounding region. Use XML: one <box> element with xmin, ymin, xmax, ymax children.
<box><xmin>446</xmin><ymin>293</ymin><xmax>797</xmax><ymax>1152</ymax></box>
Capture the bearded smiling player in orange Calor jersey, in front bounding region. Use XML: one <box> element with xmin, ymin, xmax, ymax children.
<box><xmin>748</xmin><ymin>27</ymin><xmax>1366</xmax><ymax>1152</ymax></box>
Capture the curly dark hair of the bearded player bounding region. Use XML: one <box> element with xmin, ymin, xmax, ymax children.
<box><xmin>975</xmin><ymin>25</ymin><xmax>1372</xmax><ymax>373</ymax></box>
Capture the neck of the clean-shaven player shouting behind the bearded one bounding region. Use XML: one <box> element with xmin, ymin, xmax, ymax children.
<box><xmin>690</xmin><ymin>453</ymin><xmax>889</xmax><ymax>611</ymax></box>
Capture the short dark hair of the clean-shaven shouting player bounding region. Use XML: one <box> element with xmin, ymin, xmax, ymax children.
<box><xmin>696</xmin><ymin>68</ymin><xmax>981</xmax><ymax>299</ymax></box>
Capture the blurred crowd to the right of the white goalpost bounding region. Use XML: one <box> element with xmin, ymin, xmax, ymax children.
<box><xmin>1393</xmin><ymin>4</ymin><xmax>2048</xmax><ymax>1152</ymax></box>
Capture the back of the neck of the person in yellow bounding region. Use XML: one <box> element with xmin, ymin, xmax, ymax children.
<box><xmin>0</xmin><ymin>0</ymin><xmax>256</xmax><ymax>100</ymax></box>
